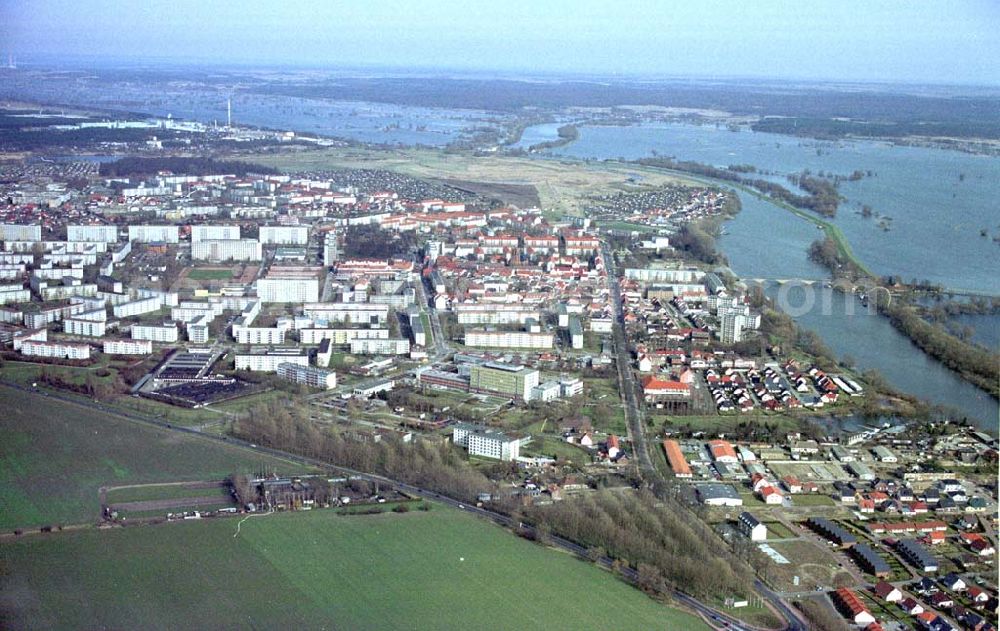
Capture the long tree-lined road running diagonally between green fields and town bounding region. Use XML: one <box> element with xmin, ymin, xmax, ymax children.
<box><xmin>0</xmin><ymin>380</ymin><xmax>788</xmax><ymax>631</ymax></box>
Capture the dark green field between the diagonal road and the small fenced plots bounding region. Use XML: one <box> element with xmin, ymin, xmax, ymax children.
<box><xmin>0</xmin><ymin>386</ymin><xmax>312</xmax><ymax>531</ymax></box>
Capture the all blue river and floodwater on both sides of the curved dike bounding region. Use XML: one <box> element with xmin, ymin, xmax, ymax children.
<box><xmin>529</xmin><ymin>123</ymin><xmax>1000</xmax><ymax>433</ymax></box>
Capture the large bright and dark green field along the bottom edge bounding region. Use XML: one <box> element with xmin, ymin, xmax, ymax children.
<box><xmin>0</xmin><ymin>506</ymin><xmax>708</xmax><ymax>629</ymax></box>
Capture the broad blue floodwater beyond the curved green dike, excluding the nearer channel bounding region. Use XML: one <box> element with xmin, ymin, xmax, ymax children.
<box><xmin>552</xmin><ymin>122</ymin><xmax>1000</xmax><ymax>295</ymax></box>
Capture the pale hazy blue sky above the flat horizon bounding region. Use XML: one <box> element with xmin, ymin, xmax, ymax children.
<box><xmin>0</xmin><ymin>0</ymin><xmax>1000</xmax><ymax>86</ymax></box>
